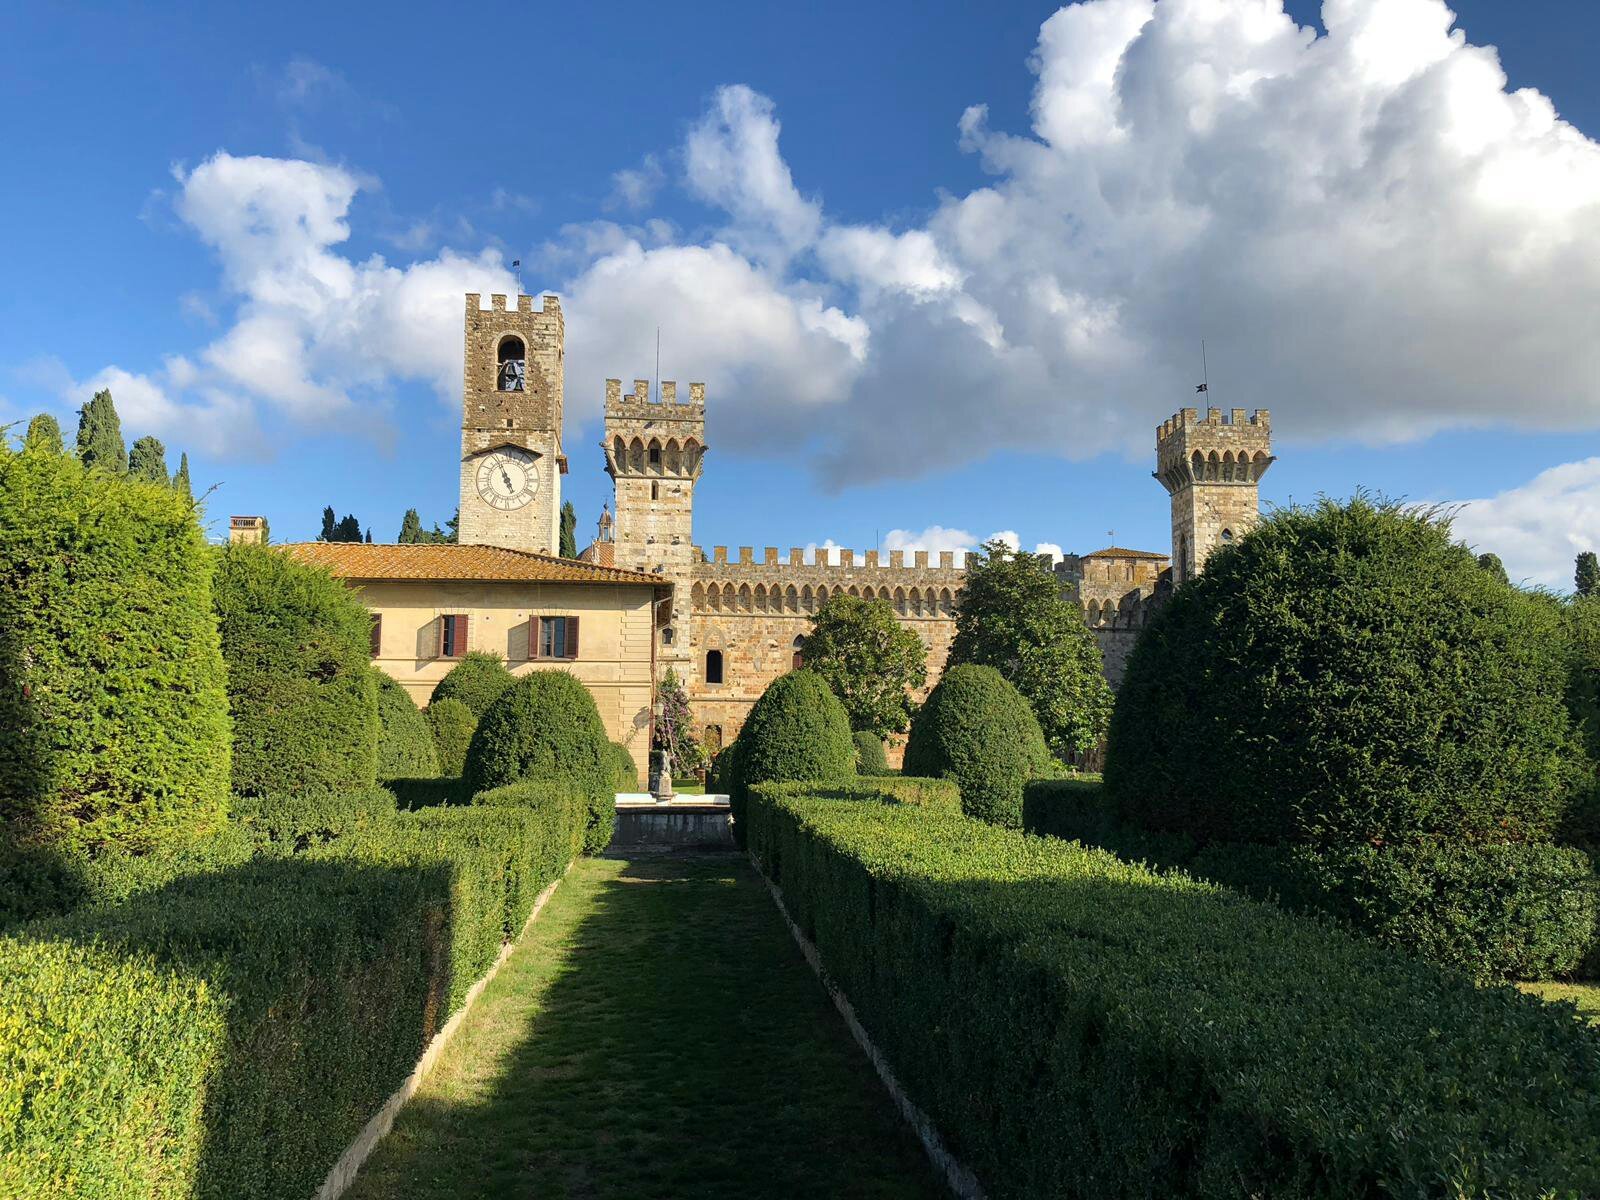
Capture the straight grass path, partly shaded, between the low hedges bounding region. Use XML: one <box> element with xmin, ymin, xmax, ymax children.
<box><xmin>347</xmin><ymin>854</ymin><xmax>941</xmax><ymax>1200</ymax></box>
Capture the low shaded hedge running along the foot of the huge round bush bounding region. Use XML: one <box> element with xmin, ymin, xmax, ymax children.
<box><xmin>1022</xmin><ymin>779</ymin><xmax>1600</xmax><ymax>979</ymax></box>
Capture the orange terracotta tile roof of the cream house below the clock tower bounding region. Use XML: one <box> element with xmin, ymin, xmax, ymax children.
<box><xmin>283</xmin><ymin>542</ymin><xmax>670</xmax><ymax>587</ymax></box>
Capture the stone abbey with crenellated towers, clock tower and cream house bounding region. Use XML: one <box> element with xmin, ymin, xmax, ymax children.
<box><xmin>272</xmin><ymin>294</ymin><xmax>1274</xmax><ymax>774</ymax></box>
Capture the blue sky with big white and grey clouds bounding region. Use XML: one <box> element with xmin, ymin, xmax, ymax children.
<box><xmin>0</xmin><ymin>0</ymin><xmax>1600</xmax><ymax>589</ymax></box>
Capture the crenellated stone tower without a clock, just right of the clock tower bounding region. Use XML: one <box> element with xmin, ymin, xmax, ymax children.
<box><xmin>602</xmin><ymin>379</ymin><xmax>706</xmax><ymax>680</ymax></box>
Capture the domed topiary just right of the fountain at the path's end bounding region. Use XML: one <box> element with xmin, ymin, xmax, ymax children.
<box><xmin>728</xmin><ymin>670</ymin><xmax>856</xmax><ymax>846</ymax></box>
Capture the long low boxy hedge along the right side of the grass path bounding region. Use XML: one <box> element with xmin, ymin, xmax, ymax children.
<box><xmin>749</xmin><ymin>787</ymin><xmax>1600</xmax><ymax>1198</ymax></box>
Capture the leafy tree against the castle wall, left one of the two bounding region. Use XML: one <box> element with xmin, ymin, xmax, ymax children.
<box><xmin>800</xmin><ymin>592</ymin><xmax>928</xmax><ymax>738</ymax></box>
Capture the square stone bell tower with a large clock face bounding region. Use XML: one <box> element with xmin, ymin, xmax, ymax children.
<box><xmin>461</xmin><ymin>293</ymin><xmax>566</xmax><ymax>554</ymax></box>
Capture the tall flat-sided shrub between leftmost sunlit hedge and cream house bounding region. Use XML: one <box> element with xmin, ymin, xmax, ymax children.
<box><xmin>216</xmin><ymin>544</ymin><xmax>378</xmax><ymax>795</ymax></box>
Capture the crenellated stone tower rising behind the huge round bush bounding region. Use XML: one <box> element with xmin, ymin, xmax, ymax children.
<box><xmin>1155</xmin><ymin>408</ymin><xmax>1274</xmax><ymax>584</ymax></box>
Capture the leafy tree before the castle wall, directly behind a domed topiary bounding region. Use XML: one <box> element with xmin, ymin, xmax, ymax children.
<box><xmin>949</xmin><ymin>541</ymin><xmax>1112</xmax><ymax>758</ymax></box>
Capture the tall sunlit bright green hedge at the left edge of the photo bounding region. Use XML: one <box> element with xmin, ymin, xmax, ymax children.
<box><xmin>0</xmin><ymin>438</ymin><xmax>229</xmax><ymax>854</ymax></box>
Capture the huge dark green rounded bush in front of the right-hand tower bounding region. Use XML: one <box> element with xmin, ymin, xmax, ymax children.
<box><xmin>1106</xmin><ymin>498</ymin><xmax>1578</xmax><ymax>846</ymax></box>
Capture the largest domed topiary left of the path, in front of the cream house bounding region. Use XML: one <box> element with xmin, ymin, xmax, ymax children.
<box><xmin>464</xmin><ymin>670</ymin><xmax>616</xmax><ymax>853</ymax></box>
